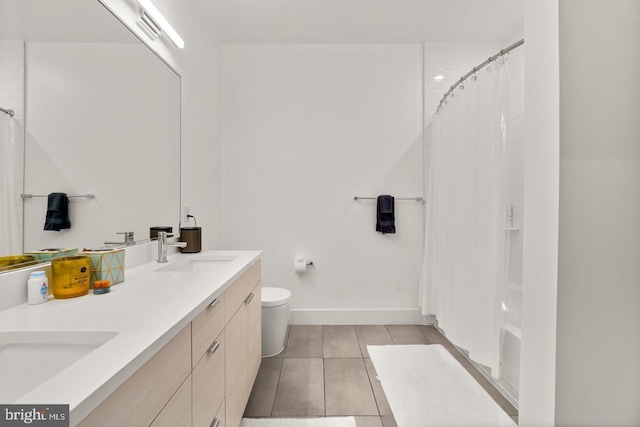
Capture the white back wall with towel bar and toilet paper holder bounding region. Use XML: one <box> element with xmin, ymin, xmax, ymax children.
<box><xmin>223</xmin><ymin>44</ymin><xmax>424</xmax><ymax>323</ymax></box>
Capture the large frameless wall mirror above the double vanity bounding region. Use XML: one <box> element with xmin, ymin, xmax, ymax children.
<box><xmin>0</xmin><ymin>0</ymin><xmax>180</xmax><ymax>264</ymax></box>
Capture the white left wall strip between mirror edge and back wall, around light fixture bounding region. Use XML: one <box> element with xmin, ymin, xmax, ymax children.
<box><xmin>100</xmin><ymin>0</ymin><xmax>223</xmax><ymax>250</ymax></box>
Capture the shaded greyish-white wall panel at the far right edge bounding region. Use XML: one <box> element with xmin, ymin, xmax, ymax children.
<box><xmin>556</xmin><ymin>0</ymin><xmax>640</xmax><ymax>426</ymax></box>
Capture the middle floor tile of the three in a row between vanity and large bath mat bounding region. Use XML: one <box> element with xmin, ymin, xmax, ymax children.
<box><xmin>271</xmin><ymin>358</ymin><xmax>325</xmax><ymax>417</ymax></box>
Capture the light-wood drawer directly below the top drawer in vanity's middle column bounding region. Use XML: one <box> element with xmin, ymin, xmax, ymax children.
<box><xmin>193</xmin><ymin>332</ymin><xmax>226</xmax><ymax>427</ymax></box>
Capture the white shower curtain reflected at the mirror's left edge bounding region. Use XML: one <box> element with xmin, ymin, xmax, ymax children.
<box><xmin>0</xmin><ymin>112</ymin><xmax>21</xmax><ymax>255</ymax></box>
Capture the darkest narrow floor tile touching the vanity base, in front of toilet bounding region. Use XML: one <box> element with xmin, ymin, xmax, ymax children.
<box><xmin>244</xmin><ymin>357</ymin><xmax>283</xmax><ymax>417</ymax></box>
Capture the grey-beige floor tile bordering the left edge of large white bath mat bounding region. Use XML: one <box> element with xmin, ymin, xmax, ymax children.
<box><xmin>324</xmin><ymin>358</ymin><xmax>379</xmax><ymax>416</ymax></box>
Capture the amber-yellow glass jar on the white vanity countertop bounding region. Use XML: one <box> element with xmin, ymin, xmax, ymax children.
<box><xmin>51</xmin><ymin>255</ymin><xmax>91</xmax><ymax>298</ymax></box>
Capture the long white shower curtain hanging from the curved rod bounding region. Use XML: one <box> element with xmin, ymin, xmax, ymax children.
<box><xmin>420</xmin><ymin>59</ymin><xmax>510</xmax><ymax>377</ymax></box>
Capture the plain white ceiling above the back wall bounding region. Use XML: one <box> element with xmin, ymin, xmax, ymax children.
<box><xmin>197</xmin><ymin>0</ymin><xmax>524</xmax><ymax>43</ymax></box>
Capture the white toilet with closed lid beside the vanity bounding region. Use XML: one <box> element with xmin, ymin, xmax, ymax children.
<box><xmin>261</xmin><ymin>287</ymin><xmax>291</xmax><ymax>357</ymax></box>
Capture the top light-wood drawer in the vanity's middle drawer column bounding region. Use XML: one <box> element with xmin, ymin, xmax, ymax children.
<box><xmin>191</xmin><ymin>293</ymin><xmax>225</xmax><ymax>367</ymax></box>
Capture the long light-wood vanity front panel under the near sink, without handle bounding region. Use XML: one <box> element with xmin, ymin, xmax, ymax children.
<box><xmin>79</xmin><ymin>324</ymin><xmax>191</xmax><ymax>427</ymax></box>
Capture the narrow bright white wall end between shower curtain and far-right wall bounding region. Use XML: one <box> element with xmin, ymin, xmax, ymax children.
<box><xmin>519</xmin><ymin>0</ymin><xmax>559</xmax><ymax>427</ymax></box>
